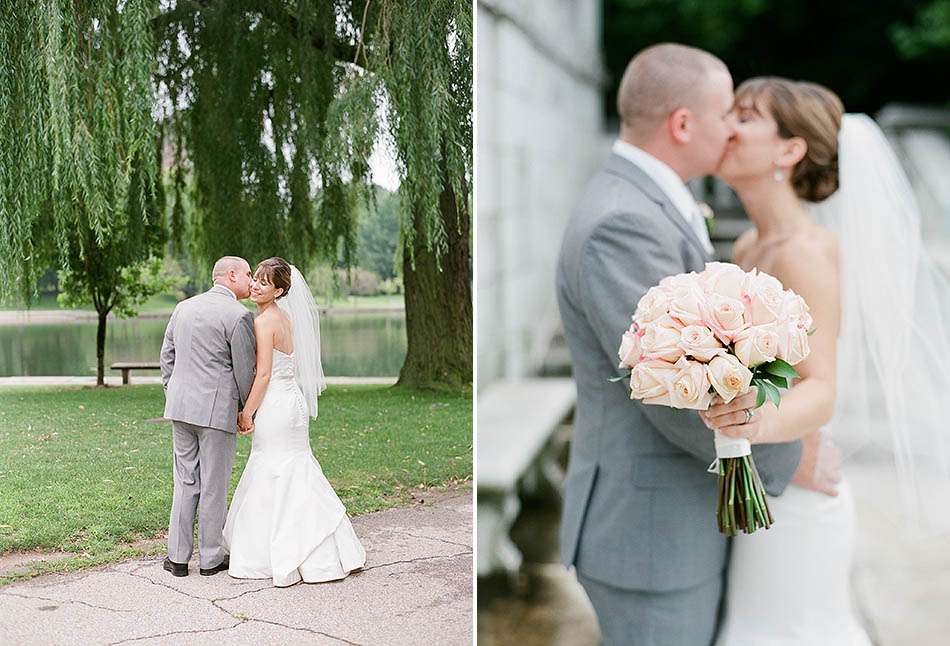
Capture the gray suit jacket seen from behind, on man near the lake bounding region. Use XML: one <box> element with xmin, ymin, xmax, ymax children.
<box><xmin>161</xmin><ymin>285</ymin><xmax>256</xmax><ymax>433</ymax></box>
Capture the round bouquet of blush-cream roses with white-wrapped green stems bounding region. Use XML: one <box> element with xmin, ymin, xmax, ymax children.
<box><xmin>612</xmin><ymin>262</ymin><xmax>812</xmax><ymax>536</ymax></box>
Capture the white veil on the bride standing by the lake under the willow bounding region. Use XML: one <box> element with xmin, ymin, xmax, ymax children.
<box><xmin>277</xmin><ymin>265</ymin><xmax>327</xmax><ymax>417</ymax></box>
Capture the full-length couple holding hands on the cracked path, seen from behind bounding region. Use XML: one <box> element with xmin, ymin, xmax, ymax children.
<box><xmin>161</xmin><ymin>256</ymin><xmax>366</xmax><ymax>586</ymax></box>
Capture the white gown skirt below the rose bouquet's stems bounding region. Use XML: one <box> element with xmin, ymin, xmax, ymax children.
<box><xmin>716</xmin><ymin>480</ymin><xmax>871</xmax><ymax>646</ymax></box>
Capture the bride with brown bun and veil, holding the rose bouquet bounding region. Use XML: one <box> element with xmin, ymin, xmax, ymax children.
<box><xmin>701</xmin><ymin>78</ymin><xmax>950</xmax><ymax>646</ymax></box>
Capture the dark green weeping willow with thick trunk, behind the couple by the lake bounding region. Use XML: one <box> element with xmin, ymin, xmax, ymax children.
<box><xmin>156</xmin><ymin>0</ymin><xmax>472</xmax><ymax>387</ymax></box>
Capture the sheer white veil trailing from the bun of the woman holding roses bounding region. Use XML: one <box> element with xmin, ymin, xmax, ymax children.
<box><xmin>809</xmin><ymin>114</ymin><xmax>950</xmax><ymax>534</ymax></box>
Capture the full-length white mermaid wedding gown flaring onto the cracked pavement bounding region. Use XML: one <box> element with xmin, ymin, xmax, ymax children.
<box><xmin>224</xmin><ymin>350</ymin><xmax>366</xmax><ymax>586</ymax></box>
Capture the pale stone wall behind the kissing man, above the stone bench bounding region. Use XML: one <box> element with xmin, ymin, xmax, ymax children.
<box><xmin>475</xmin><ymin>0</ymin><xmax>604</xmax><ymax>387</ymax></box>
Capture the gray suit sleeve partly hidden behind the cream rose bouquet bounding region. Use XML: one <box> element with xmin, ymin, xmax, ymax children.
<box><xmin>578</xmin><ymin>213</ymin><xmax>801</xmax><ymax>495</ymax></box>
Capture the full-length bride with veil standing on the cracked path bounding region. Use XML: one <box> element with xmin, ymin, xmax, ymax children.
<box><xmin>224</xmin><ymin>258</ymin><xmax>366</xmax><ymax>586</ymax></box>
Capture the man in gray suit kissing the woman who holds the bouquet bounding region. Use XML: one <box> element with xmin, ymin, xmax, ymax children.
<box><xmin>557</xmin><ymin>44</ymin><xmax>840</xmax><ymax>646</ymax></box>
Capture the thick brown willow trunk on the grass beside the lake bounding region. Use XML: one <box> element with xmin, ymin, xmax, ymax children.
<box><xmin>398</xmin><ymin>172</ymin><xmax>473</xmax><ymax>389</ymax></box>
